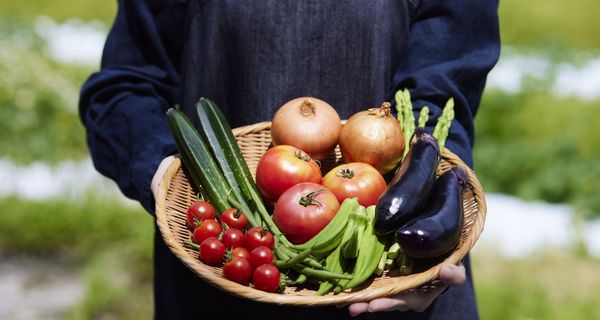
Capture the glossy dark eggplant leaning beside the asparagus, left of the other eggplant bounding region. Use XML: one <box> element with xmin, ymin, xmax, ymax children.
<box><xmin>375</xmin><ymin>128</ymin><xmax>440</xmax><ymax>235</ymax></box>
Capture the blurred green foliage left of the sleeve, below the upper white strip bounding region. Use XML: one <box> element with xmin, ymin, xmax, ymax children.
<box><xmin>0</xmin><ymin>35</ymin><xmax>90</xmax><ymax>163</ymax></box>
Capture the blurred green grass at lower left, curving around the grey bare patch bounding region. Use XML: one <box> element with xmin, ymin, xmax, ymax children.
<box><xmin>0</xmin><ymin>196</ymin><xmax>154</xmax><ymax>319</ymax></box>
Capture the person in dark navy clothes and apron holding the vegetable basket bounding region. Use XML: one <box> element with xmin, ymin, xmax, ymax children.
<box><xmin>80</xmin><ymin>0</ymin><xmax>500</xmax><ymax>319</ymax></box>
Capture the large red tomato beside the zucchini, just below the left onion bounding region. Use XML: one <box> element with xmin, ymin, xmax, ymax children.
<box><xmin>256</xmin><ymin>145</ymin><xmax>322</xmax><ymax>203</ymax></box>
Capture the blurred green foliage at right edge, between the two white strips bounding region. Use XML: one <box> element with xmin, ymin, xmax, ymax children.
<box><xmin>474</xmin><ymin>92</ymin><xmax>600</xmax><ymax>215</ymax></box>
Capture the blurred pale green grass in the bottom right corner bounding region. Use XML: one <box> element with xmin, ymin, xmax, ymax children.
<box><xmin>472</xmin><ymin>248</ymin><xmax>600</xmax><ymax>320</ymax></box>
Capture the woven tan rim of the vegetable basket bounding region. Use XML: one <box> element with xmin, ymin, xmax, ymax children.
<box><xmin>156</xmin><ymin>122</ymin><xmax>487</xmax><ymax>307</ymax></box>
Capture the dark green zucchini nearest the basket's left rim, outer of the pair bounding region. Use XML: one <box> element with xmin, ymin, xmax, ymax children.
<box><xmin>167</xmin><ymin>108</ymin><xmax>231</xmax><ymax>216</ymax></box>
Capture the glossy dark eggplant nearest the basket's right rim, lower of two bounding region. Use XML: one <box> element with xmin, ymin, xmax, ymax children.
<box><xmin>396</xmin><ymin>167</ymin><xmax>467</xmax><ymax>258</ymax></box>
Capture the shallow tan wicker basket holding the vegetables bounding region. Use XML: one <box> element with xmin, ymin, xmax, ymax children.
<box><xmin>156</xmin><ymin>122</ymin><xmax>486</xmax><ymax>307</ymax></box>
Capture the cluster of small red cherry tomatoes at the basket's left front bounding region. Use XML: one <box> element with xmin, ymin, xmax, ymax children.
<box><xmin>187</xmin><ymin>200</ymin><xmax>280</xmax><ymax>292</ymax></box>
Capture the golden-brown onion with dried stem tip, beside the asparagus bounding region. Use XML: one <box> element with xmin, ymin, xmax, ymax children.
<box><xmin>339</xmin><ymin>102</ymin><xmax>404</xmax><ymax>174</ymax></box>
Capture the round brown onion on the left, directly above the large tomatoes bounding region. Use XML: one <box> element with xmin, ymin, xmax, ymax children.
<box><xmin>271</xmin><ymin>97</ymin><xmax>342</xmax><ymax>160</ymax></box>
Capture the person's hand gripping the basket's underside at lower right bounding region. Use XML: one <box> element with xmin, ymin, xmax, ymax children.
<box><xmin>348</xmin><ymin>263</ymin><xmax>466</xmax><ymax>317</ymax></box>
